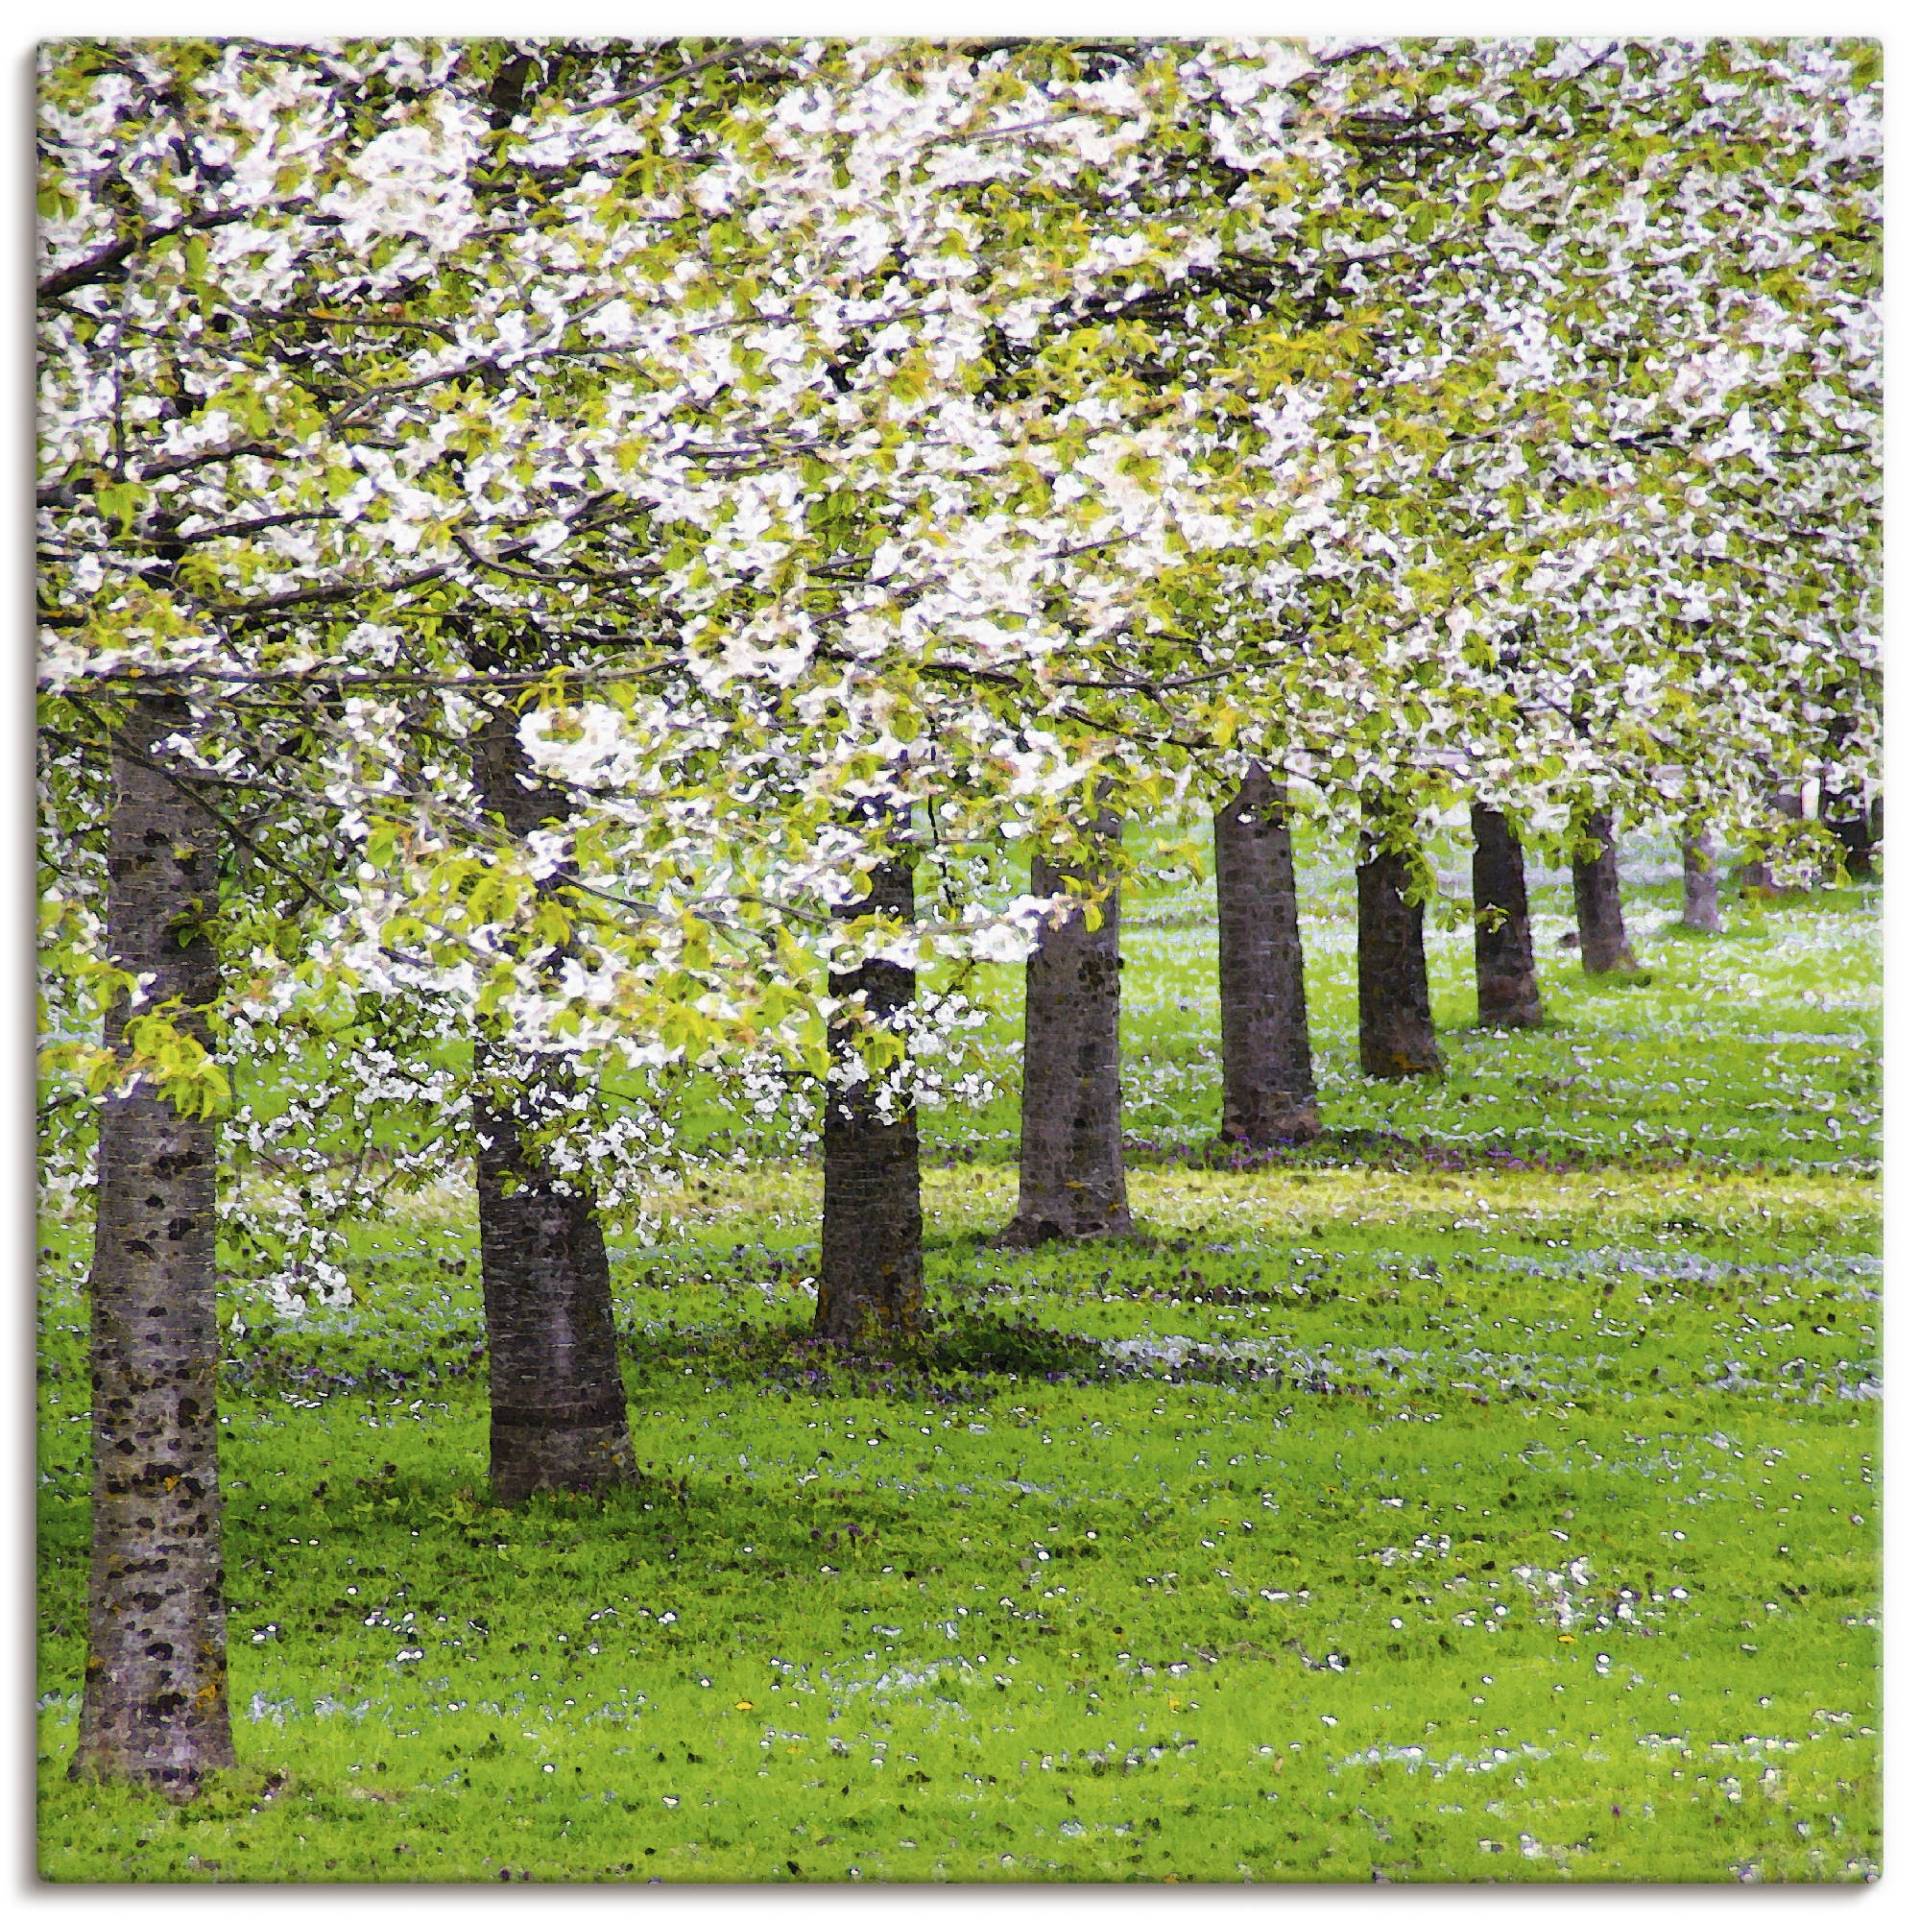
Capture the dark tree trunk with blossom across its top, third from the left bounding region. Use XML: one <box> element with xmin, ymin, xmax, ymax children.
<box><xmin>814</xmin><ymin>860</ymin><xmax>925</xmax><ymax>1344</ymax></box>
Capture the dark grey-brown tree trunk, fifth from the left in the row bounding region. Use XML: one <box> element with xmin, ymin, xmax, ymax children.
<box><xmin>1213</xmin><ymin>766</ymin><xmax>1321</xmax><ymax>1146</ymax></box>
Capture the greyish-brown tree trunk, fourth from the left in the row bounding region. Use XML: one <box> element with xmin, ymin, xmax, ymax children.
<box><xmin>1006</xmin><ymin>822</ymin><xmax>1133</xmax><ymax>1244</ymax></box>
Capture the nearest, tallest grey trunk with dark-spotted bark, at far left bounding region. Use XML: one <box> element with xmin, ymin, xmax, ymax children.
<box><xmin>73</xmin><ymin>697</ymin><xmax>234</xmax><ymax>1799</ymax></box>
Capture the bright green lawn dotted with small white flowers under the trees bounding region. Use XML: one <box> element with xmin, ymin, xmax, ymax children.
<box><xmin>38</xmin><ymin>833</ymin><xmax>1884</xmax><ymax>1882</ymax></box>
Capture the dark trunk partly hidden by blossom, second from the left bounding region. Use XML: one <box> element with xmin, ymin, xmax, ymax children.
<box><xmin>472</xmin><ymin>683</ymin><xmax>634</xmax><ymax>1507</ymax></box>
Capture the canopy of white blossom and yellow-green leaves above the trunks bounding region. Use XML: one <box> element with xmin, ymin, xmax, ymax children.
<box><xmin>38</xmin><ymin>40</ymin><xmax>1880</xmax><ymax>1260</ymax></box>
